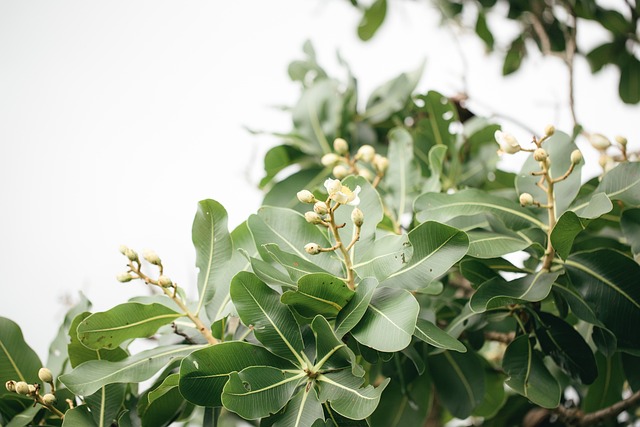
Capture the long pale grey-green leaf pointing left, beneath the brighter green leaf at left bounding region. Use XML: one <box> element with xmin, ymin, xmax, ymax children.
<box><xmin>59</xmin><ymin>345</ymin><xmax>203</xmax><ymax>396</ymax></box>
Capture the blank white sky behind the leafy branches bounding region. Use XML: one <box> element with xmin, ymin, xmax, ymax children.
<box><xmin>0</xmin><ymin>0</ymin><xmax>640</xmax><ymax>359</ymax></box>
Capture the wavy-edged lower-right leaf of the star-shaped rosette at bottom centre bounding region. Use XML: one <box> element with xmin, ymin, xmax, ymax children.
<box><xmin>317</xmin><ymin>371</ymin><xmax>389</xmax><ymax>420</ymax></box>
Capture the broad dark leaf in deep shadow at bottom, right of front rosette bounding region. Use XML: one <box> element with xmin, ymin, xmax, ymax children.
<box><xmin>427</xmin><ymin>351</ymin><xmax>484</xmax><ymax>418</ymax></box>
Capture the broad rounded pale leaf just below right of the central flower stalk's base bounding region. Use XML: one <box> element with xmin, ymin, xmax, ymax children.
<box><xmin>351</xmin><ymin>288</ymin><xmax>420</xmax><ymax>352</ymax></box>
